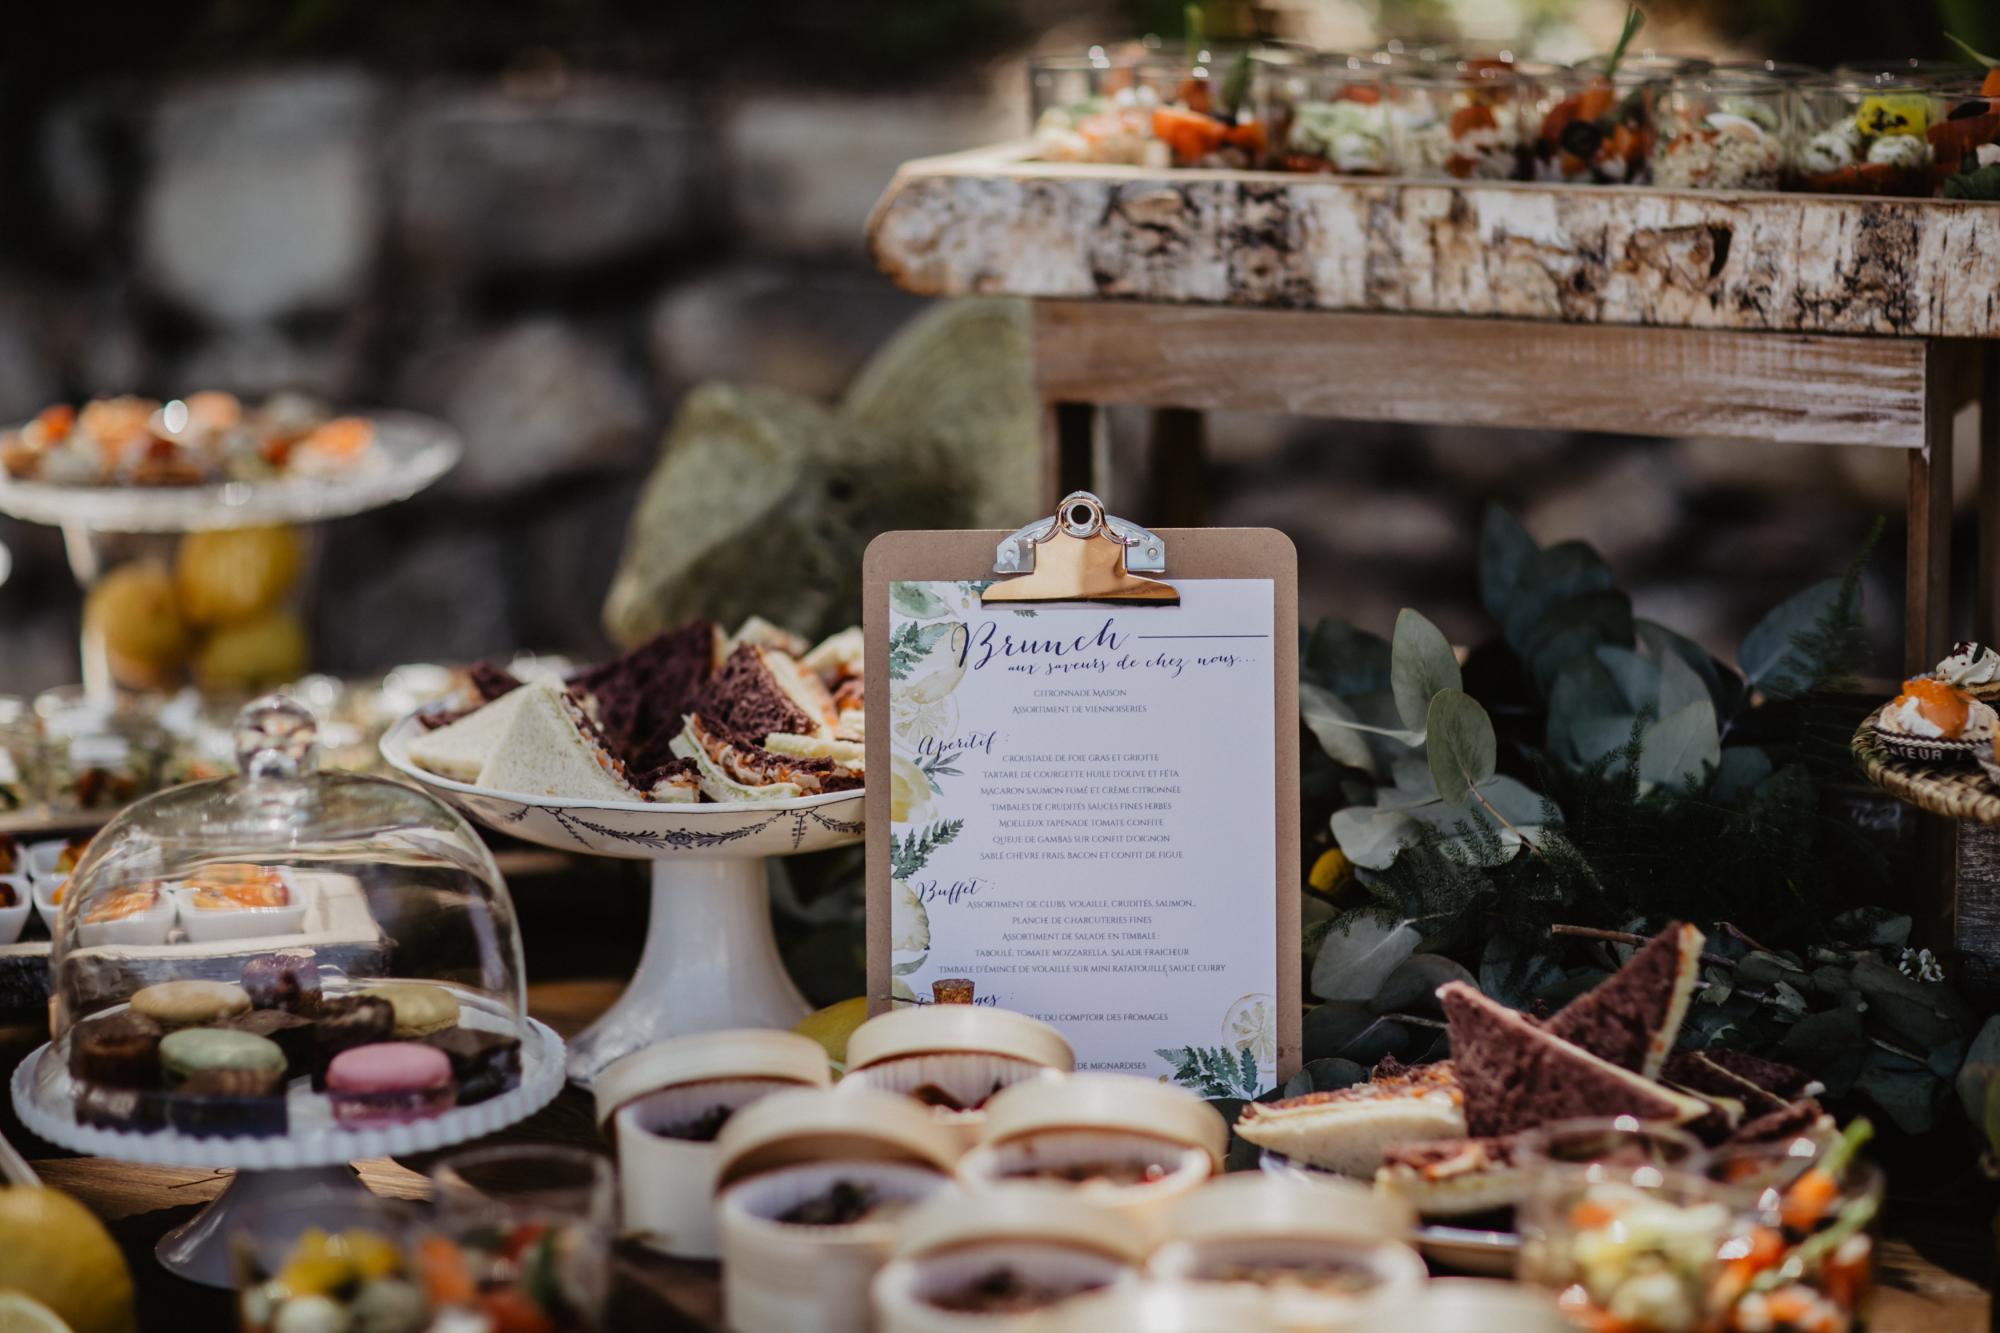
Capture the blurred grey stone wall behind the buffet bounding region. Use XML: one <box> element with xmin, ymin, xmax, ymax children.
<box><xmin>0</xmin><ymin>0</ymin><xmax>1972</xmax><ymax>693</ymax></box>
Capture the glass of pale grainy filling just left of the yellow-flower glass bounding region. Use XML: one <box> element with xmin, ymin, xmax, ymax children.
<box><xmin>1652</xmin><ymin>74</ymin><xmax>1794</xmax><ymax>190</ymax></box>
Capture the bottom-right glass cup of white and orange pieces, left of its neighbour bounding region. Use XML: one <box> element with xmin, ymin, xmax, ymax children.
<box><xmin>1516</xmin><ymin>1159</ymin><xmax>1736</xmax><ymax>1333</ymax></box>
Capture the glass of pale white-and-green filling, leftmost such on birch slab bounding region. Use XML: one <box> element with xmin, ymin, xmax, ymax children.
<box><xmin>1250</xmin><ymin>52</ymin><xmax>1394</xmax><ymax>176</ymax></box>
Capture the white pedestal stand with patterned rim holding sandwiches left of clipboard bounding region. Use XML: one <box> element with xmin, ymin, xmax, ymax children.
<box><xmin>382</xmin><ymin>717</ymin><xmax>862</xmax><ymax>1087</ymax></box>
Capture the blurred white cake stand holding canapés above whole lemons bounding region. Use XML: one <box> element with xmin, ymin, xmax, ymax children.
<box><xmin>0</xmin><ymin>412</ymin><xmax>460</xmax><ymax>699</ymax></box>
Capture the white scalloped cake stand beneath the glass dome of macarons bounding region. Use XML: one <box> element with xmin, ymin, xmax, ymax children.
<box><xmin>14</xmin><ymin>1019</ymin><xmax>564</xmax><ymax>1287</ymax></box>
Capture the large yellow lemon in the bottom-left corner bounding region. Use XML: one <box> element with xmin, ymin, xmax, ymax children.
<box><xmin>0</xmin><ymin>1187</ymin><xmax>134</xmax><ymax>1333</ymax></box>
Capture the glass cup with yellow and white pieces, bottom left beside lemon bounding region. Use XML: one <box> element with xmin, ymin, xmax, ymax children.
<box><xmin>230</xmin><ymin>1189</ymin><xmax>432</xmax><ymax>1333</ymax></box>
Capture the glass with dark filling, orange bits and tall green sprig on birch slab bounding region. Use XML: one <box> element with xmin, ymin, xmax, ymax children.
<box><xmin>1528</xmin><ymin>60</ymin><xmax>1666</xmax><ymax>184</ymax></box>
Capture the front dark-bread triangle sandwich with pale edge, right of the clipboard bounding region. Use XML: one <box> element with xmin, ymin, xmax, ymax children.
<box><xmin>1438</xmin><ymin>981</ymin><xmax>1708</xmax><ymax>1139</ymax></box>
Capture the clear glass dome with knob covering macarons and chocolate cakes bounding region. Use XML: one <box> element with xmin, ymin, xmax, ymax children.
<box><xmin>32</xmin><ymin>697</ymin><xmax>532</xmax><ymax>1139</ymax></box>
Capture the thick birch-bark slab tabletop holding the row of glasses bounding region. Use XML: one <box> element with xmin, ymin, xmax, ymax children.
<box><xmin>868</xmin><ymin>144</ymin><xmax>2000</xmax><ymax>338</ymax></box>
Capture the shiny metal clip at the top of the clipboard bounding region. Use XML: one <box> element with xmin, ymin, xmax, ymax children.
<box><xmin>980</xmin><ymin>490</ymin><xmax>1180</xmax><ymax>606</ymax></box>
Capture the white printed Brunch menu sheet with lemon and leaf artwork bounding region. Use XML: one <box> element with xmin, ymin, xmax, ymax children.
<box><xmin>888</xmin><ymin>578</ymin><xmax>1296</xmax><ymax>1091</ymax></box>
